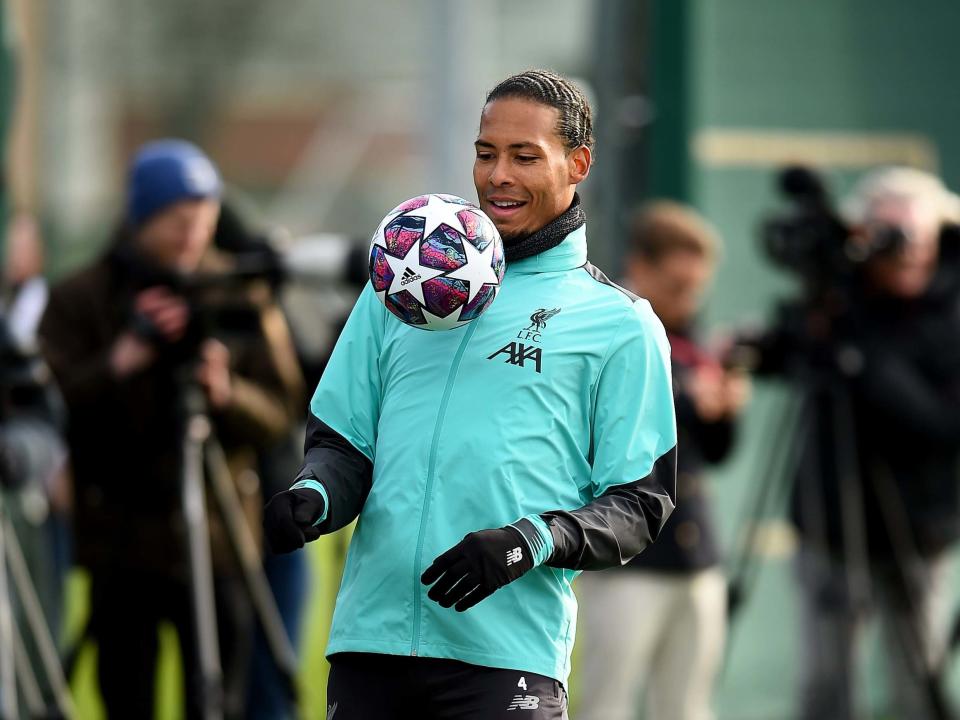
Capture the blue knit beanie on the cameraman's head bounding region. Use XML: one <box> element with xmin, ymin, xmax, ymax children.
<box><xmin>127</xmin><ymin>140</ymin><xmax>223</xmax><ymax>226</ymax></box>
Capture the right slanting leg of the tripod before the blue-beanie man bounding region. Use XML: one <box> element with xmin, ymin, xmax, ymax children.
<box><xmin>207</xmin><ymin>437</ymin><xmax>297</xmax><ymax>702</ymax></box>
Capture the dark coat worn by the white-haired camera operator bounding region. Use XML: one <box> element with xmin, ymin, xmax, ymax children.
<box><xmin>766</xmin><ymin>274</ymin><xmax>960</xmax><ymax>559</ymax></box>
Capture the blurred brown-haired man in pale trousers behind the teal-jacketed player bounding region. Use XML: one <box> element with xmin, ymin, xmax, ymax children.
<box><xmin>577</xmin><ymin>201</ymin><xmax>747</xmax><ymax>720</ymax></box>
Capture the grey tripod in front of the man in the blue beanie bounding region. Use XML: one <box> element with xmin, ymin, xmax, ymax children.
<box><xmin>180</xmin><ymin>372</ymin><xmax>297</xmax><ymax>720</ymax></box>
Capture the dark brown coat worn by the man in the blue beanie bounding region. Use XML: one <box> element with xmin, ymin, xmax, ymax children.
<box><xmin>40</xmin><ymin>233</ymin><xmax>304</xmax><ymax>578</ymax></box>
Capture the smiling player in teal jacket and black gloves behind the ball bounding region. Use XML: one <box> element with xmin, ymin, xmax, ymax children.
<box><xmin>265</xmin><ymin>71</ymin><xmax>676</xmax><ymax>720</ymax></box>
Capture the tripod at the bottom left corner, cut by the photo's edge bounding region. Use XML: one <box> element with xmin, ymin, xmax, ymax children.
<box><xmin>0</xmin><ymin>494</ymin><xmax>77</xmax><ymax>720</ymax></box>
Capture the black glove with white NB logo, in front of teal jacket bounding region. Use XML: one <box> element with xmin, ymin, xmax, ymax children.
<box><xmin>420</xmin><ymin>525</ymin><xmax>534</xmax><ymax>612</ymax></box>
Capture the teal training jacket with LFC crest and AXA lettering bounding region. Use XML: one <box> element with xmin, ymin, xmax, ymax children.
<box><xmin>311</xmin><ymin>227</ymin><xmax>676</xmax><ymax>682</ymax></box>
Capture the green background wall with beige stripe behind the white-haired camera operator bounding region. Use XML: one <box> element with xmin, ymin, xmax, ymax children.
<box><xmin>664</xmin><ymin>0</ymin><xmax>960</xmax><ymax>720</ymax></box>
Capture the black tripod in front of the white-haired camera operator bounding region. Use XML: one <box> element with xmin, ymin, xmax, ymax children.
<box><xmin>728</xmin><ymin>368</ymin><xmax>954</xmax><ymax>720</ymax></box>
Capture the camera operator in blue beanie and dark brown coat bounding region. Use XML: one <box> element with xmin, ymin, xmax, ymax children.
<box><xmin>40</xmin><ymin>140</ymin><xmax>301</xmax><ymax>718</ymax></box>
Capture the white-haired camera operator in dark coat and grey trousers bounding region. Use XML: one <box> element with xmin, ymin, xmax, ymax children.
<box><xmin>761</xmin><ymin>168</ymin><xmax>960</xmax><ymax>720</ymax></box>
